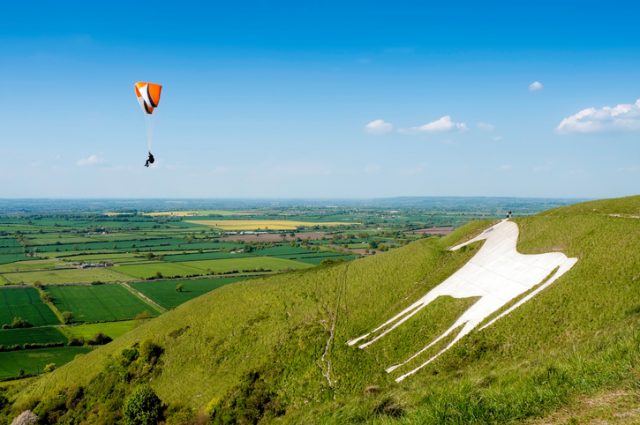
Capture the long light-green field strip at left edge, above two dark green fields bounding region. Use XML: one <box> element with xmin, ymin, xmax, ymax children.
<box><xmin>2</xmin><ymin>268</ymin><xmax>131</xmax><ymax>285</ymax></box>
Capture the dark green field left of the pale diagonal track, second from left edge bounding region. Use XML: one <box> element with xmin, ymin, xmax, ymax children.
<box><xmin>46</xmin><ymin>284</ymin><xmax>158</xmax><ymax>322</ymax></box>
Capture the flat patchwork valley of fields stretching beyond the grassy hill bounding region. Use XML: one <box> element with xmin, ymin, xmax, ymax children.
<box><xmin>0</xmin><ymin>199</ymin><xmax>568</xmax><ymax>379</ymax></box>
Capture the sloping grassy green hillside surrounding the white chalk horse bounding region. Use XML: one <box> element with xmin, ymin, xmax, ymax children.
<box><xmin>0</xmin><ymin>197</ymin><xmax>640</xmax><ymax>424</ymax></box>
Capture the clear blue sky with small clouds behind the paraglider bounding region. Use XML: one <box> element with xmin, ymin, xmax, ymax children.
<box><xmin>0</xmin><ymin>1</ymin><xmax>640</xmax><ymax>198</ymax></box>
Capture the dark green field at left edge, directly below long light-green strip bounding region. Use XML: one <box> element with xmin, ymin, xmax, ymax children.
<box><xmin>0</xmin><ymin>287</ymin><xmax>60</xmax><ymax>326</ymax></box>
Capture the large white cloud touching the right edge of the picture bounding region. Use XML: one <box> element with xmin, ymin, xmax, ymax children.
<box><xmin>556</xmin><ymin>99</ymin><xmax>640</xmax><ymax>134</ymax></box>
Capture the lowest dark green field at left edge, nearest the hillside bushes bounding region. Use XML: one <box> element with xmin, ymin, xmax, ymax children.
<box><xmin>0</xmin><ymin>347</ymin><xmax>90</xmax><ymax>379</ymax></box>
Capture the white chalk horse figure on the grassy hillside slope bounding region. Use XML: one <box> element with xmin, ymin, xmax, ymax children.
<box><xmin>348</xmin><ymin>220</ymin><xmax>578</xmax><ymax>382</ymax></box>
